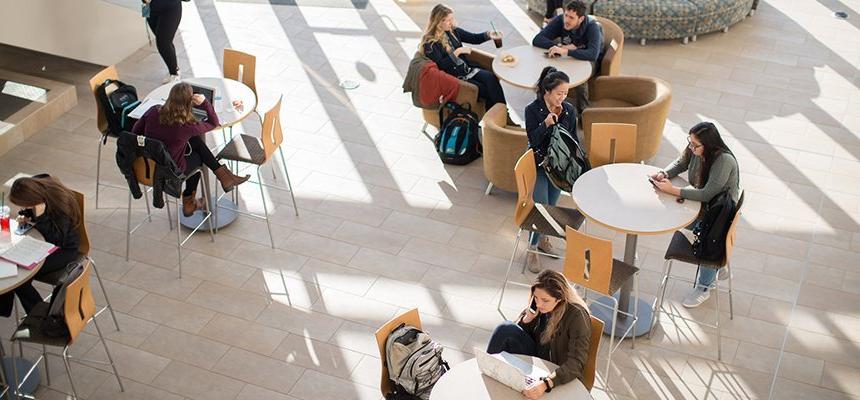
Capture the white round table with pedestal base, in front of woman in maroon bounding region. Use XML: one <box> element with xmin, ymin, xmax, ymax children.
<box><xmin>140</xmin><ymin>77</ymin><xmax>257</xmax><ymax>229</ymax></box>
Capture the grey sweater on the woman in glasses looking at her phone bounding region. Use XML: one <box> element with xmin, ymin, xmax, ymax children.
<box><xmin>664</xmin><ymin>151</ymin><xmax>740</xmax><ymax>203</ymax></box>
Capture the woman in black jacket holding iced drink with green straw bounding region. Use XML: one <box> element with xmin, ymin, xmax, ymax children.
<box><xmin>418</xmin><ymin>4</ymin><xmax>507</xmax><ymax>110</ymax></box>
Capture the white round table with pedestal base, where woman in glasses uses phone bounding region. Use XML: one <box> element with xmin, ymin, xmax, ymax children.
<box><xmin>571</xmin><ymin>164</ymin><xmax>701</xmax><ymax>337</ymax></box>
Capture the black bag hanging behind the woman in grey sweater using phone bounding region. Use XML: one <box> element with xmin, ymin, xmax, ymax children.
<box><xmin>693</xmin><ymin>190</ymin><xmax>736</xmax><ymax>262</ymax></box>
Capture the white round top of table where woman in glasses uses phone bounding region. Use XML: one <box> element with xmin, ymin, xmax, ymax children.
<box><xmin>571</xmin><ymin>164</ymin><xmax>700</xmax><ymax>235</ymax></box>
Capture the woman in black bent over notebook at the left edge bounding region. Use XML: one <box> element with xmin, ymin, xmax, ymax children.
<box><xmin>0</xmin><ymin>175</ymin><xmax>84</xmax><ymax>317</ymax></box>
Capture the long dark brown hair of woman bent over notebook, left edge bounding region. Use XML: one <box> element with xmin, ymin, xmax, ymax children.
<box><xmin>9</xmin><ymin>175</ymin><xmax>82</xmax><ymax>227</ymax></box>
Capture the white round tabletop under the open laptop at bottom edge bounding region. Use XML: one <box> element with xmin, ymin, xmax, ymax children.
<box><xmin>430</xmin><ymin>355</ymin><xmax>592</xmax><ymax>400</ymax></box>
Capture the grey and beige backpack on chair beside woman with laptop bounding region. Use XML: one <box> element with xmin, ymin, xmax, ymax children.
<box><xmin>385</xmin><ymin>324</ymin><xmax>450</xmax><ymax>400</ymax></box>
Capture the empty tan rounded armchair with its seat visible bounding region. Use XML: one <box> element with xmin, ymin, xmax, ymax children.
<box><xmin>582</xmin><ymin>76</ymin><xmax>672</xmax><ymax>162</ymax></box>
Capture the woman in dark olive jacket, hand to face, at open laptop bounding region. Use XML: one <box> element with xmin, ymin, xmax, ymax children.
<box><xmin>487</xmin><ymin>269</ymin><xmax>591</xmax><ymax>399</ymax></box>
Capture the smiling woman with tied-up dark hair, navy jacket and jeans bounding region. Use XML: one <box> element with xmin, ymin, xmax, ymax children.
<box><xmin>526</xmin><ymin>67</ymin><xmax>576</xmax><ymax>273</ymax></box>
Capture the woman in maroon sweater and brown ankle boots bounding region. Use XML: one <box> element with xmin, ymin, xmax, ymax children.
<box><xmin>131</xmin><ymin>83</ymin><xmax>251</xmax><ymax>217</ymax></box>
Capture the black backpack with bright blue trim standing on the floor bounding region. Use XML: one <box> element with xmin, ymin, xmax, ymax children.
<box><xmin>433</xmin><ymin>102</ymin><xmax>483</xmax><ymax>165</ymax></box>
